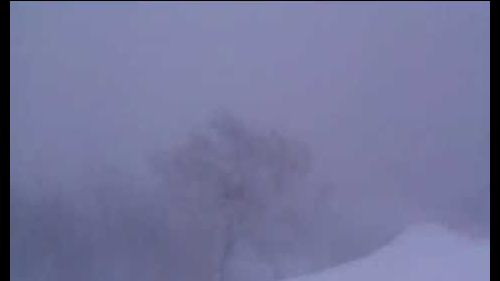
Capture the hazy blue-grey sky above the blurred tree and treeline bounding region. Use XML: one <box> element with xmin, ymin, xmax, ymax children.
<box><xmin>10</xmin><ymin>2</ymin><xmax>490</xmax><ymax>228</ymax></box>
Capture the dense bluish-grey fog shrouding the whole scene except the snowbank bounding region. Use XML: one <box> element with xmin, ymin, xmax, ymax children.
<box><xmin>10</xmin><ymin>2</ymin><xmax>490</xmax><ymax>281</ymax></box>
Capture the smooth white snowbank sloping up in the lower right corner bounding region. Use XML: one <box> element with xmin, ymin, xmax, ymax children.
<box><xmin>286</xmin><ymin>224</ymin><xmax>490</xmax><ymax>281</ymax></box>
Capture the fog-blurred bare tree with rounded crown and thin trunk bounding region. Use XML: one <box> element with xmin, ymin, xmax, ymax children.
<box><xmin>150</xmin><ymin>110</ymin><xmax>309</xmax><ymax>280</ymax></box>
